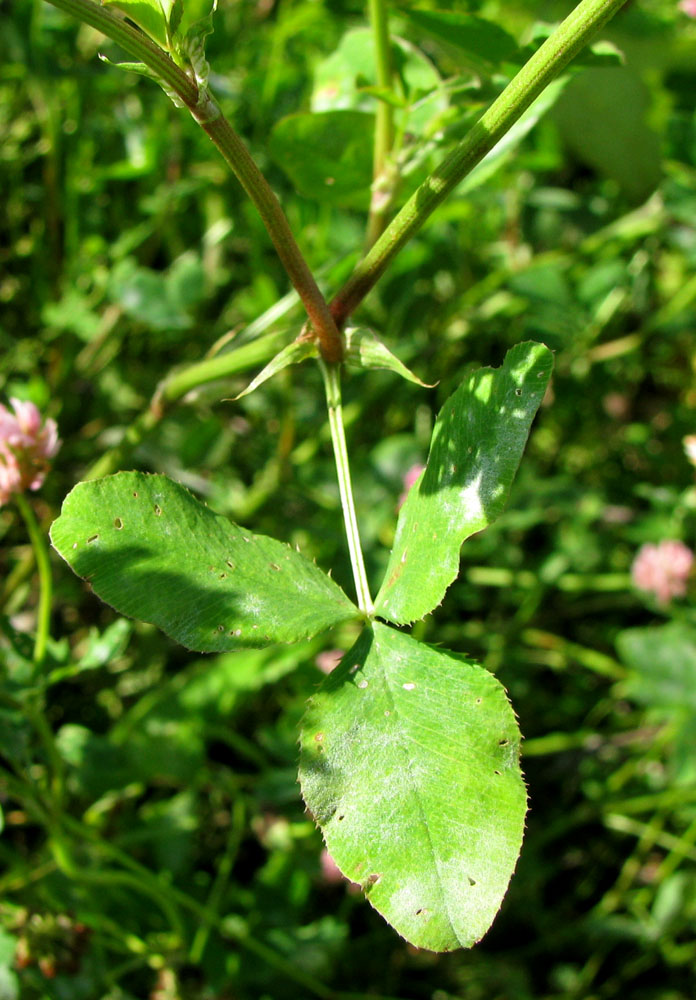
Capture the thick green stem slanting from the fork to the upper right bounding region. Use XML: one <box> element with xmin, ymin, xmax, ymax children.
<box><xmin>331</xmin><ymin>0</ymin><xmax>626</xmax><ymax>328</ymax></box>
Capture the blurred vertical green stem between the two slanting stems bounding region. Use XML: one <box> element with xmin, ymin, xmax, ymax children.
<box><xmin>366</xmin><ymin>0</ymin><xmax>394</xmax><ymax>248</ymax></box>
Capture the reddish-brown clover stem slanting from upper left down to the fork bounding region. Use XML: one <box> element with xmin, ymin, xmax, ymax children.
<box><xmin>42</xmin><ymin>0</ymin><xmax>343</xmax><ymax>363</ymax></box>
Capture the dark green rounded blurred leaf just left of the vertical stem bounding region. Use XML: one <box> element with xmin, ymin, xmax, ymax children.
<box><xmin>269</xmin><ymin>111</ymin><xmax>374</xmax><ymax>209</ymax></box>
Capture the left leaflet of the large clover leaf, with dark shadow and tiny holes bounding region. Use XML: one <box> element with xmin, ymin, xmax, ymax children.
<box><xmin>51</xmin><ymin>472</ymin><xmax>360</xmax><ymax>652</ymax></box>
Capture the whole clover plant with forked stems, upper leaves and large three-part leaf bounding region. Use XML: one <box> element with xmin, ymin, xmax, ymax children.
<box><xmin>44</xmin><ymin>0</ymin><xmax>623</xmax><ymax>951</ymax></box>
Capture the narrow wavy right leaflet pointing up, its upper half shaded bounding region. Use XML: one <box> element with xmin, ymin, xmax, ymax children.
<box><xmin>375</xmin><ymin>344</ymin><xmax>553</xmax><ymax>625</ymax></box>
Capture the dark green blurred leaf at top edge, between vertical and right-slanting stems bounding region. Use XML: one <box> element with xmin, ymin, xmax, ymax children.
<box><xmin>399</xmin><ymin>9</ymin><xmax>518</xmax><ymax>65</ymax></box>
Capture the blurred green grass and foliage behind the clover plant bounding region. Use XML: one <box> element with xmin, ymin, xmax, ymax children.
<box><xmin>0</xmin><ymin>0</ymin><xmax>696</xmax><ymax>1000</ymax></box>
